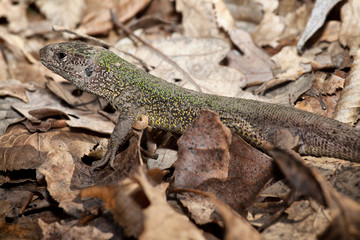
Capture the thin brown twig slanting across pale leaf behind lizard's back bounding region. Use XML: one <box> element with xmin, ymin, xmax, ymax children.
<box><xmin>110</xmin><ymin>10</ymin><xmax>202</xmax><ymax>92</ymax></box>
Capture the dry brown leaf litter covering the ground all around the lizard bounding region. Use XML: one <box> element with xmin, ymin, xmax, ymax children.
<box><xmin>0</xmin><ymin>0</ymin><xmax>360</xmax><ymax>239</ymax></box>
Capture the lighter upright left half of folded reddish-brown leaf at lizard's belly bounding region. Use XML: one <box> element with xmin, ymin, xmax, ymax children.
<box><xmin>174</xmin><ymin>111</ymin><xmax>231</xmax><ymax>188</ymax></box>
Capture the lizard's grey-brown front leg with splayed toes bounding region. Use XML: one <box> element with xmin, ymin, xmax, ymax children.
<box><xmin>91</xmin><ymin>114</ymin><xmax>135</xmax><ymax>171</ymax></box>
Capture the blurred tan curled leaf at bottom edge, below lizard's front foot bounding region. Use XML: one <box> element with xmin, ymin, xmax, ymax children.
<box><xmin>81</xmin><ymin>168</ymin><xmax>204</xmax><ymax>239</ymax></box>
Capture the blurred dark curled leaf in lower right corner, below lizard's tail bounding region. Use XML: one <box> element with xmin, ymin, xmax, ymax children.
<box><xmin>266</xmin><ymin>133</ymin><xmax>360</xmax><ymax>239</ymax></box>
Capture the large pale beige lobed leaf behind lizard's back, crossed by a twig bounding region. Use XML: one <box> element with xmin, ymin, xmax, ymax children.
<box><xmin>136</xmin><ymin>38</ymin><xmax>245</xmax><ymax>96</ymax></box>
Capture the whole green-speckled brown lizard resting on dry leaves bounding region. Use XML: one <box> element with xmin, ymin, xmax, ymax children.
<box><xmin>40</xmin><ymin>41</ymin><xmax>360</xmax><ymax>170</ymax></box>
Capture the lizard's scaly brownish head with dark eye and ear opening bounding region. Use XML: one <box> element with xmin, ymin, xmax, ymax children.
<box><xmin>40</xmin><ymin>41</ymin><xmax>112</xmax><ymax>97</ymax></box>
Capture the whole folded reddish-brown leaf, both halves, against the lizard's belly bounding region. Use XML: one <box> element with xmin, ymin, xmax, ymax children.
<box><xmin>174</xmin><ymin>111</ymin><xmax>273</xmax><ymax>213</ymax></box>
